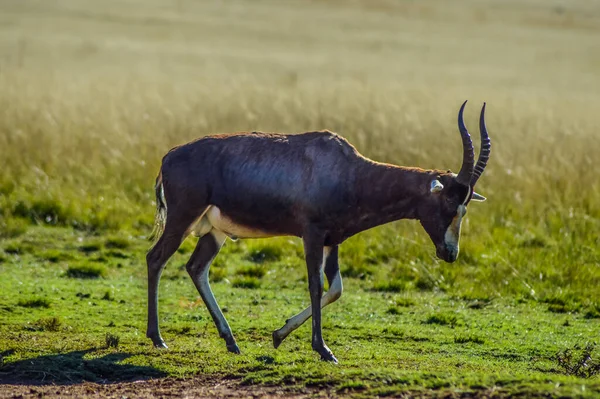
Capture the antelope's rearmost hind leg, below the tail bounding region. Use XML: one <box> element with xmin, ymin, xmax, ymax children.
<box><xmin>146</xmin><ymin>213</ymin><xmax>195</xmax><ymax>348</ymax></box>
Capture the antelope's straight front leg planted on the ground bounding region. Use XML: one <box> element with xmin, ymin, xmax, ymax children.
<box><xmin>302</xmin><ymin>229</ymin><xmax>337</xmax><ymax>363</ymax></box>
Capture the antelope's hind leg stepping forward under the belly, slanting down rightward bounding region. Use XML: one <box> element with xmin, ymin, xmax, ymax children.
<box><xmin>186</xmin><ymin>229</ymin><xmax>240</xmax><ymax>353</ymax></box>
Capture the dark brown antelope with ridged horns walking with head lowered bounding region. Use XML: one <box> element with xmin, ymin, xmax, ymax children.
<box><xmin>146</xmin><ymin>101</ymin><xmax>491</xmax><ymax>363</ymax></box>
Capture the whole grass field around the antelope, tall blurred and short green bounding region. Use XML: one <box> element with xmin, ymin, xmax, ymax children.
<box><xmin>0</xmin><ymin>0</ymin><xmax>600</xmax><ymax>397</ymax></box>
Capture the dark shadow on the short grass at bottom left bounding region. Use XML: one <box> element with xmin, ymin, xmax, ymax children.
<box><xmin>0</xmin><ymin>349</ymin><xmax>166</xmax><ymax>385</ymax></box>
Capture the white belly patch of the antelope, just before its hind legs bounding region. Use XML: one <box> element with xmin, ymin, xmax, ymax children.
<box><xmin>191</xmin><ymin>205</ymin><xmax>277</xmax><ymax>240</ymax></box>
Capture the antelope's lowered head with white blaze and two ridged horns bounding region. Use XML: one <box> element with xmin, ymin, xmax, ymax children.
<box><xmin>418</xmin><ymin>101</ymin><xmax>491</xmax><ymax>263</ymax></box>
